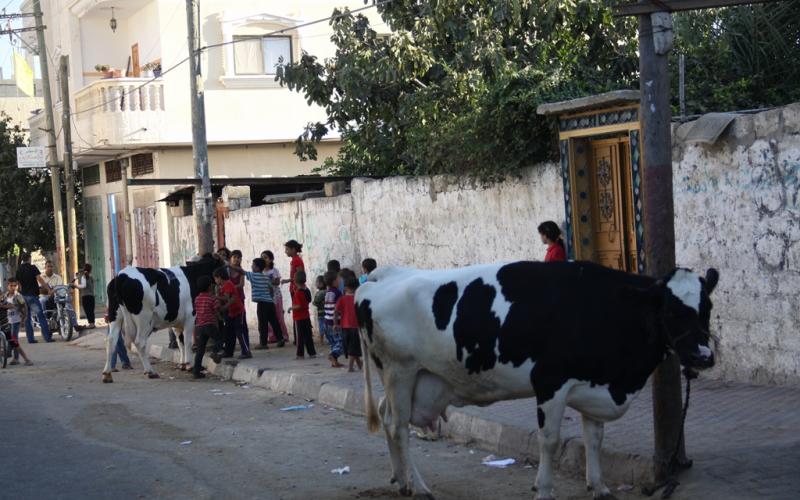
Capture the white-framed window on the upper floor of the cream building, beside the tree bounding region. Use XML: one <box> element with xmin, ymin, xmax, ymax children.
<box><xmin>233</xmin><ymin>36</ymin><xmax>292</xmax><ymax>75</ymax></box>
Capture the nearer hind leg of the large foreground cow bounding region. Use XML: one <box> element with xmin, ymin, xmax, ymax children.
<box><xmin>384</xmin><ymin>366</ymin><xmax>433</xmax><ymax>498</ymax></box>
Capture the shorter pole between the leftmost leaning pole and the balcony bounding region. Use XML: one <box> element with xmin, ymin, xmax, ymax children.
<box><xmin>59</xmin><ymin>55</ymin><xmax>79</xmax><ymax>311</ymax></box>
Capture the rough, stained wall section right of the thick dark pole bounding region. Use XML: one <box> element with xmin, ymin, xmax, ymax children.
<box><xmin>673</xmin><ymin>104</ymin><xmax>800</xmax><ymax>384</ymax></box>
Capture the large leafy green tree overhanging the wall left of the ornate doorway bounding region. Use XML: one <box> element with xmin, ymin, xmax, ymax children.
<box><xmin>276</xmin><ymin>0</ymin><xmax>638</xmax><ymax>179</ymax></box>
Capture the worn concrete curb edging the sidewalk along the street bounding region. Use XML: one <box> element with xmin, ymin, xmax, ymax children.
<box><xmin>150</xmin><ymin>345</ymin><xmax>653</xmax><ymax>484</ymax></box>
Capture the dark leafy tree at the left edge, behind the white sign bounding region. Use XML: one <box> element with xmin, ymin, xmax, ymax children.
<box><xmin>0</xmin><ymin>115</ymin><xmax>55</xmax><ymax>259</ymax></box>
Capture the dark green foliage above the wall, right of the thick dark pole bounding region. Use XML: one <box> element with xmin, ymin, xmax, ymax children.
<box><xmin>670</xmin><ymin>0</ymin><xmax>800</xmax><ymax>115</ymax></box>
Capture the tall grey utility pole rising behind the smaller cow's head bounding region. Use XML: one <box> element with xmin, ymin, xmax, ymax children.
<box><xmin>186</xmin><ymin>0</ymin><xmax>214</xmax><ymax>255</ymax></box>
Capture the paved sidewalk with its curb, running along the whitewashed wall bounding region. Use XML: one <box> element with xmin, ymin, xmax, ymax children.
<box><xmin>73</xmin><ymin>330</ymin><xmax>800</xmax><ymax>499</ymax></box>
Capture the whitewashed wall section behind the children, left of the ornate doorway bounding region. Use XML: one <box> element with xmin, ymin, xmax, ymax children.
<box><xmin>220</xmin><ymin>164</ymin><xmax>564</xmax><ymax>336</ymax></box>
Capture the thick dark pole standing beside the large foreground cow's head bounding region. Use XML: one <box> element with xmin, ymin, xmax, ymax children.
<box><xmin>639</xmin><ymin>8</ymin><xmax>682</xmax><ymax>482</ymax></box>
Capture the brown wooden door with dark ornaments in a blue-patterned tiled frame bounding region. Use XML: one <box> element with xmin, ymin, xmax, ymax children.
<box><xmin>589</xmin><ymin>138</ymin><xmax>636</xmax><ymax>271</ymax></box>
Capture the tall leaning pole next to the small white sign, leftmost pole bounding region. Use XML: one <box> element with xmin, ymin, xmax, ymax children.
<box><xmin>33</xmin><ymin>0</ymin><xmax>67</xmax><ymax>277</ymax></box>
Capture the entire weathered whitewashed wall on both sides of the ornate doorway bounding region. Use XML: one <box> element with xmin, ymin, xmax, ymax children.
<box><xmin>214</xmin><ymin>104</ymin><xmax>800</xmax><ymax>384</ymax></box>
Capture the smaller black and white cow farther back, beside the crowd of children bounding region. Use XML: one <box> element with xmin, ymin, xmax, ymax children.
<box><xmin>103</xmin><ymin>256</ymin><xmax>224</xmax><ymax>383</ymax></box>
